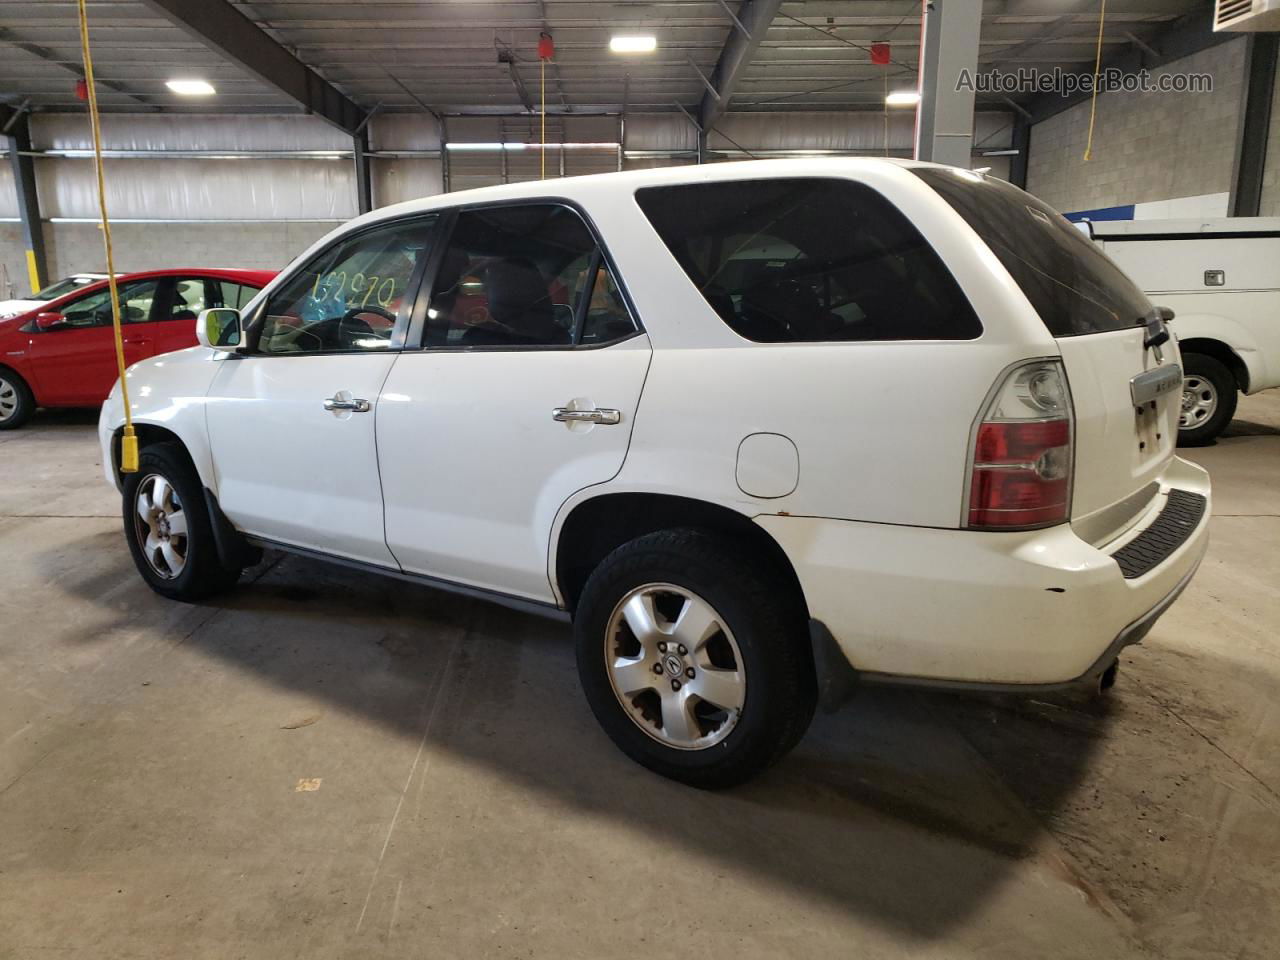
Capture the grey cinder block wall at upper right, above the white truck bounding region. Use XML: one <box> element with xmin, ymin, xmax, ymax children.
<box><xmin>1027</xmin><ymin>37</ymin><xmax>1249</xmax><ymax>210</ymax></box>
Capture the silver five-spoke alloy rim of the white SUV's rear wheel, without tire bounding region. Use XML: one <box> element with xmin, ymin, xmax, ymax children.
<box><xmin>604</xmin><ymin>584</ymin><xmax>746</xmax><ymax>750</ymax></box>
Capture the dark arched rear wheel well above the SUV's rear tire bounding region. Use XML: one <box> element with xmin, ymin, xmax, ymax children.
<box><xmin>556</xmin><ymin>493</ymin><xmax>809</xmax><ymax>620</ymax></box>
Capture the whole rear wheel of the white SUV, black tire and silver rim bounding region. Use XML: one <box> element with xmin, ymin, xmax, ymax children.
<box><xmin>573</xmin><ymin>530</ymin><xmax>817</xmax><ymax>788</ymax></box>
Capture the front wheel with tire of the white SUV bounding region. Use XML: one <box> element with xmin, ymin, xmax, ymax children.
<box><xmin>123</xmin><ymin>443</ymin><xmax>241</xmax><ymax>602</ymax></box>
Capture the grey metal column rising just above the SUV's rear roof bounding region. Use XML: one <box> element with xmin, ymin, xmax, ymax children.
<box><xmin>915</xmin><ymin>0</ymin><xmax>982</xmax><ymax>169</ymax></box>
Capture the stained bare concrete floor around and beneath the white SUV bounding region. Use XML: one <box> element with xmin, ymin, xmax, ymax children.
<box><xmin>0</xmin><ymin>392</ymin><xmax>1280</xmax><ymax>960</ymax></box>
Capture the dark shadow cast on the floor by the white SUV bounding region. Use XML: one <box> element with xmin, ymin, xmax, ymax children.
<box><xmin>50</xmin><ymin>534</ymin><xmax>1111</xmax><ymax>940</ymax></box>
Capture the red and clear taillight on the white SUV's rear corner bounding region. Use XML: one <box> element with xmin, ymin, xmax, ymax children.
<box><xmin>969</xmin><ymin>360</ymin><xmax>1074</xmax><ymax>530</ymax></box>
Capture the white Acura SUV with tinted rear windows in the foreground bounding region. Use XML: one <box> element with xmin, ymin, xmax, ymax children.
<box><xmin>100</xmin><ymin>160</ymin><xmax>1210</xmax><ymax>786</ymax></box>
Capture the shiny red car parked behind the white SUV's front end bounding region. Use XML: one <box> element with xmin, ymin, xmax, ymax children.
<box><xmin>0</xmin><ymin>269</ymin><xmax>275</xmax><ymax>430</ymax></box>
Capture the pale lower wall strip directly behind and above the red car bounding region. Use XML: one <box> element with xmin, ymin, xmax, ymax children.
<box><xmin>0</xmin><ymin>220</ymin><xmax>338</xmax><ymax>298</ymax></box>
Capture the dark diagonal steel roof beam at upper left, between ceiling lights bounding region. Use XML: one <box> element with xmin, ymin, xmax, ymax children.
<box><xmin>142</xmin><ymin>0</ymin><xmax>365</xmax><ymax>134</ymax></box>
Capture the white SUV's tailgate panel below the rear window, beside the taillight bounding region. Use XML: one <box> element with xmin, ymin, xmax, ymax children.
<box><xmin>1057</xmin><ymin>326</ymin><xmax>1181</xmax><ymax>529</ymax></box>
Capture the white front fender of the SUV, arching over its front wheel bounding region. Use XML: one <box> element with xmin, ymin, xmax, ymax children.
<box><xmin>99</xmin><ymin>347</ymin><xmax>227</xmax><ymax>493</ymax></box>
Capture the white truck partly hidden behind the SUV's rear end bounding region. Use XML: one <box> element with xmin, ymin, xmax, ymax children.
<box><xmin>1087</xmin><ymin>216</ymin><xmax>1280</xmax><ymax>447</ymax></box>
